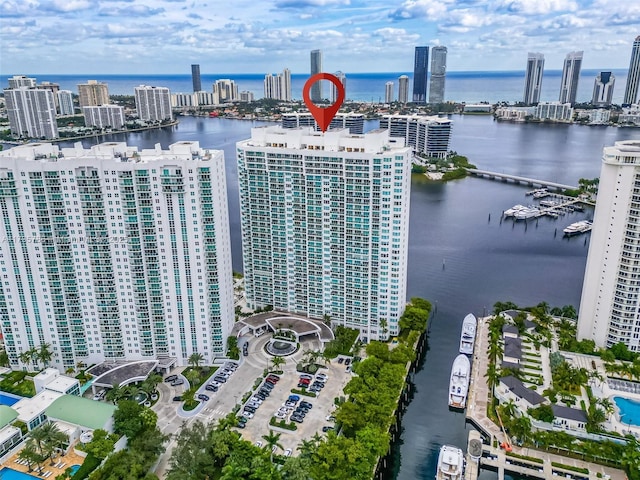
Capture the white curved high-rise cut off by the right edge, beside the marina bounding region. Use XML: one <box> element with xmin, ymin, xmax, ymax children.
<box><xmin>578</xmin><ymin>140</ymin><xmax>640</xmax><ymax>352</ymax></box>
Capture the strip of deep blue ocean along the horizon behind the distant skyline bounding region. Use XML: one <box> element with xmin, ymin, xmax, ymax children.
<box><xmin>4</xmin><ymin>69</ymin><xmax>627</xmax><ymax>104</ymax></box>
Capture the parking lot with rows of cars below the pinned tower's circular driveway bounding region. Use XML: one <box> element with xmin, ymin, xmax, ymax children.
<box><xmin>238</xmin><ymin>360</ymin><xmax>351</xmax><ymax>455</ymax></box>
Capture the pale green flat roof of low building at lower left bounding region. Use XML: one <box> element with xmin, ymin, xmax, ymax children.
<box><xmin>46</xmin><ymin>395</ymin><xmax>116</xmax><ymax>430</ymax></box>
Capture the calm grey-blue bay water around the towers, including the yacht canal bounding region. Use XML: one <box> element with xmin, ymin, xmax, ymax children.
<box><xmin>65</xmin><ymin>116</ymin><xmax>640</xmax><ymax>480</ymax></box>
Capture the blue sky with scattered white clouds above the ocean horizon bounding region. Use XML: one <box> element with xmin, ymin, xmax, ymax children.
<box><xmin>0</xmin><ymin>0</ymin><xmax>640</xmax><ymax>76</ymax></box>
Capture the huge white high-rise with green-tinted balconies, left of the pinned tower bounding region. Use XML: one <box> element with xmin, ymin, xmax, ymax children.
<box><xmin>0</xmin><ymin>141</ymin><xmax>234</xmax><ymax>371</ymax></box>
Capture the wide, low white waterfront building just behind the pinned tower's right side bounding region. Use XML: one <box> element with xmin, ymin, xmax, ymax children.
<box><xmin>380</xmin><ymin>115</ymin><xmax>453</xmax><ymax>158</ymax></box>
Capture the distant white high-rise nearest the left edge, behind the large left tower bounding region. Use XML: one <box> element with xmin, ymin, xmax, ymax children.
<box><xmin>4</xmin><ymin>87</ymin><xmax>58</xmax><ymax>139</ymax></box>
